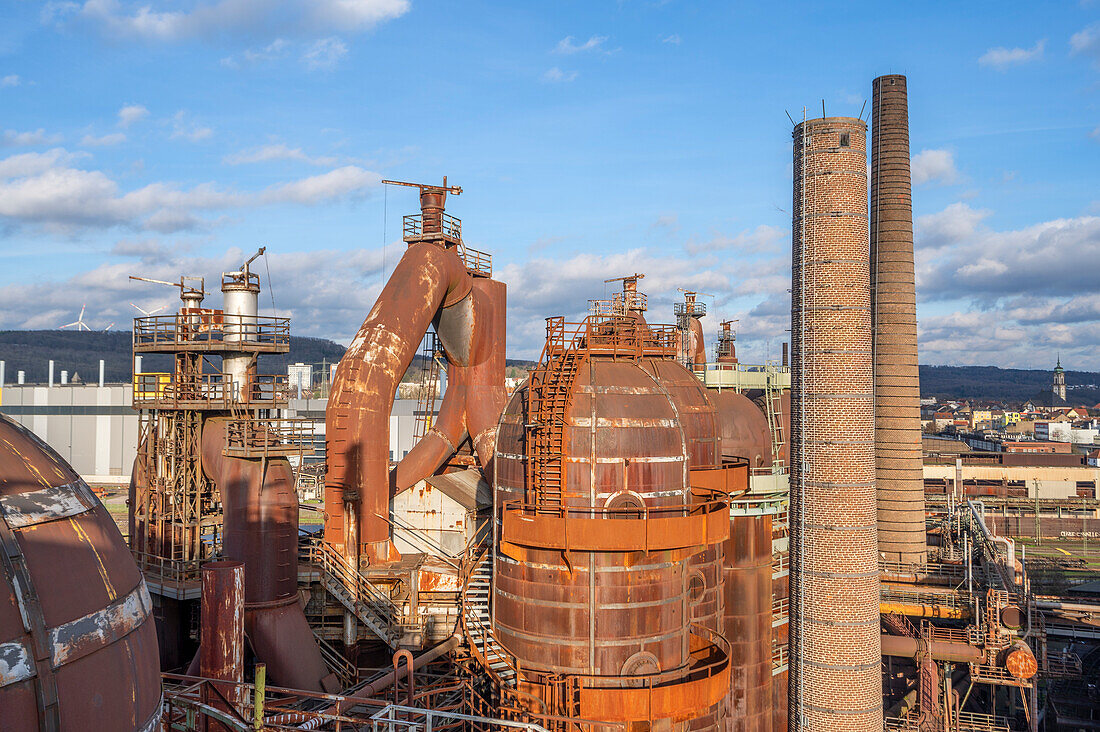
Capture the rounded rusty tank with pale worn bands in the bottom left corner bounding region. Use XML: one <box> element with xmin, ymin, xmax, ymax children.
<box><xmin>0</xmin><ymin>416</ymin><xmax>161</xmax><ymax>732</ymax></box>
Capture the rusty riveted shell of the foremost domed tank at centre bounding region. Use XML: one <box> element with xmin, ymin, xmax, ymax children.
<box><xmin>494</xmin><ymin>358</ymin><xmax>690</xmax><ymax>677</ymax></box>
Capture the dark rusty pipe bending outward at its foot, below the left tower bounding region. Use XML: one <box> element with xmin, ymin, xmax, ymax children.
<box><xmin>202</xmin><ymin>418</ymin><xmax>339</xmax><ymax>691</ymax></box>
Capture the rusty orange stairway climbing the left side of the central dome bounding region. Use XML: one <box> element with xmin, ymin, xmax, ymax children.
<box><xmin>526</xmin><ymin>317</ymin><xmax>583</xmax><ymax>510</ymax></box>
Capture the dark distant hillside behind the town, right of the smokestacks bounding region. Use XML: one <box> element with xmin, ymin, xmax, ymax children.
<box><xmin>921</xmin><ymin>365</ymin><xmax>1100</xmax><ymax>406</ymax></box>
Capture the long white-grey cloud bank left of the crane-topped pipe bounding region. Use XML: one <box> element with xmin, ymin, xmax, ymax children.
<box><xmin>0</xmin><ymin>149</ymin><xmax>381</xmax><ymax>232</ymax></box>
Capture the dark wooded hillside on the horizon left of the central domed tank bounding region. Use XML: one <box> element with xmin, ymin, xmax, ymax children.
<box><xmin>0</xmin><ymin>330</ymin><xmax>535</xmax><ymax>384</ymax></box>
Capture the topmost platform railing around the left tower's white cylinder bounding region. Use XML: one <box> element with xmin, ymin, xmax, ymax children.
<box><xmin>133</xmin><ymin>309</ymin><xmax>290</xmax><ymax>352</ymax></box>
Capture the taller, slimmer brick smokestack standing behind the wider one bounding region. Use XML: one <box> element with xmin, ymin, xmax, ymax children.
<box><xmin>870</xmin><ymin>75</ymin><xmax>927</xmax><ymax>564</ymax></box>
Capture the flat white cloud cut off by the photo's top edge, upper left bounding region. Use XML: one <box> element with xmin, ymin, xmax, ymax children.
<box><xmin>53</xmin><ymin>0</ymin><xmax>410</xmax><ymax>42</ymax></box>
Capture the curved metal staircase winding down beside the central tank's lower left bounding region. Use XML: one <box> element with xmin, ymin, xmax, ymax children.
<box><xmin>462</xmin><ymin>522</ymin><xmax>517</xmax><ymax>688</ymax></box>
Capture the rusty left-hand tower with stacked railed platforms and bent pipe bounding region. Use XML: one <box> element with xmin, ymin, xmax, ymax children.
<box><xmin>130</xmin><ymin>254</ymin><xmax>325</xmax><ymax>691</ymax></box>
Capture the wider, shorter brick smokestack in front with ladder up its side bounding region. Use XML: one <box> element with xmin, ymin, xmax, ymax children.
<box><xmin>790</xmin><ymin>118</ymin><xmax>882</xmax><ymax>732</ymax></box>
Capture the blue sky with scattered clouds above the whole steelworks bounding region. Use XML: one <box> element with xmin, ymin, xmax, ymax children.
<box><xmin>0</xmin><ymin>0</ymin><xmax>1100</xmax><ymax>369</ymax></box>
